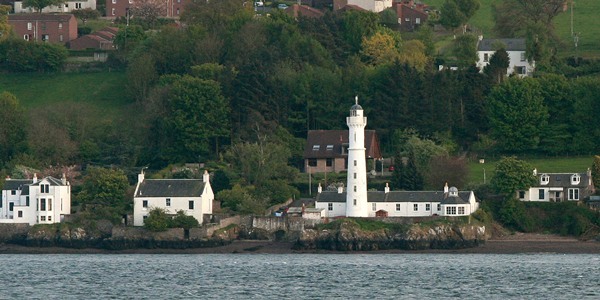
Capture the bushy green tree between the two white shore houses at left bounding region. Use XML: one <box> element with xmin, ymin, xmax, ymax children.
<box><xmin>78</xmin><ymin>167</ymin><xmax>131</xmax><ymax>222</ymax></box>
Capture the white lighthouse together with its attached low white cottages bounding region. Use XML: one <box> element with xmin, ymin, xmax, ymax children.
<box><xmin>315</xmin><ymin>99</ymin><xmax>479</xmax><ymax>218</ymax></box>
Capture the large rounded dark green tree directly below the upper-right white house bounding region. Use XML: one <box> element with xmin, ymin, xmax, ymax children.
<box><xmin>486</xmin><ymin>77</ymin><xmax>548</xmax><ymax>153</ymax></box>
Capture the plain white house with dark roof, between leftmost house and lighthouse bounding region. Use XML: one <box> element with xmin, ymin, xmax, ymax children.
<box><xmin>133</xmin><ymin>171</ymin><xmax>215</xmax><ymax>226</ymax></box>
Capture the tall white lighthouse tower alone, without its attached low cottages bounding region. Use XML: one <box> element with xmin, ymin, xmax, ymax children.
<box><xmin>346</xmin><ymin>96</ymin><xmax>369</xmax><ymax>217</ymax></box>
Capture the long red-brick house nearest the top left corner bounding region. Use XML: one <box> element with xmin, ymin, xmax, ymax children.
<box><xmin>8</xmin><ymin>14</ymin><xmax>77</xmax><ymax>45</ymax></box>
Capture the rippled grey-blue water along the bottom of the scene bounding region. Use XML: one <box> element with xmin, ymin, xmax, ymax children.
<box><xmin>0</xmin><ymin>254</ymin><xmax>600</xmax><ymax>299</ymax></box>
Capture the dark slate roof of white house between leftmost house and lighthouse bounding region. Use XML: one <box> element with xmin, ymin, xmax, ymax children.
<box><xmin>135</xmin><ymin>179</ymin><xmax>205</xmax><ymax>197</ymax></box>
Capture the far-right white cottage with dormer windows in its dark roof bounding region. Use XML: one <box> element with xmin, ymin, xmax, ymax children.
<box><xmin>517</xmin><ymin>169</ymin><xmax>594</xmax><ymax>202</ymax></box>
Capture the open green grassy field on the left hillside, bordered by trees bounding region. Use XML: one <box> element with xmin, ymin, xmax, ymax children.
<box><xmin>0</xmin><ymin>72</ymin><xmax>131</xmax><ymax>114</ymax></box>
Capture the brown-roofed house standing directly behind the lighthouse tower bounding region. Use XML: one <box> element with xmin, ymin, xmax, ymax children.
<box><xmin>304</xmin><ymin>130</ymin><xmax>382</xmax><ymax>173</ymax></box>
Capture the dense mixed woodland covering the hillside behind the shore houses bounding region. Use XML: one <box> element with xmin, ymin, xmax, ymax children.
<box><xmin>0</xmin><ymin>0</ymin><xmax>600</xmax><ymax>223</ymax></box>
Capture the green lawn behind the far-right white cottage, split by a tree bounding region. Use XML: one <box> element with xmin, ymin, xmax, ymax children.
<box><xmin>468</xmin><ymin>156</ymin><xmax>594</xmax><ymax>184</ymax></box>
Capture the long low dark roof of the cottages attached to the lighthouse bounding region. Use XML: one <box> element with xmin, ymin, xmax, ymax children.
<box><xmin>316</xmin><ymin>191</ymin><xmax>471</xmax><ymax>204</ymax></box>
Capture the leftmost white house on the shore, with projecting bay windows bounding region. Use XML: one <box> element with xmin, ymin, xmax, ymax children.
<box><xmin>0</xmin><ymin>174</ymin><xmax>71</xmax><ymax>225</ymax></box>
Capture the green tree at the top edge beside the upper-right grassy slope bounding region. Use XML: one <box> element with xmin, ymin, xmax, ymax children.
<box><xmin>440</xmin><ymin>0</ymin><xmax>480</xmax><ymax>33</ymax></box>
